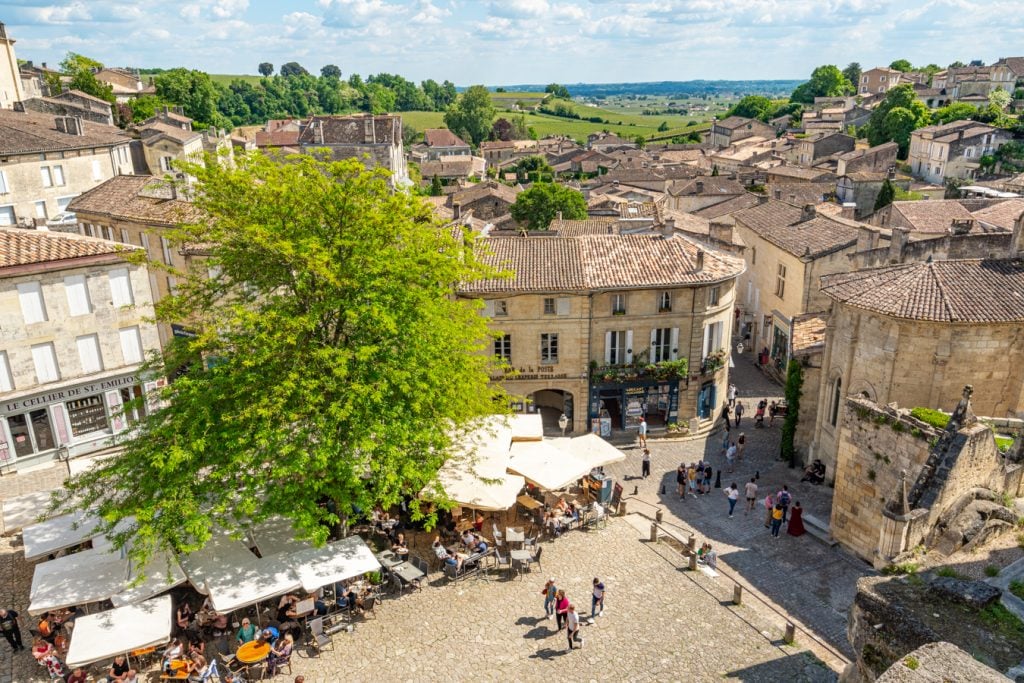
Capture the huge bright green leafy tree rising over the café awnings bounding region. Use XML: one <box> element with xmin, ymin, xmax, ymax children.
<box><xmin>58</xmin><ymin>154</ymin><xmax>505</xmax><ymax>560</ymax></box>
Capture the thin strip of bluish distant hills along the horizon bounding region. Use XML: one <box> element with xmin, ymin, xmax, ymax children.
<box><xmin>487</xmin><ymin>80</ymin><xmax>804</xmax><ymax>97</ymax></box>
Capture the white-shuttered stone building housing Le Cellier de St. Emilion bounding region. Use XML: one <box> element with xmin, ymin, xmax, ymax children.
<box><xmin>0</xmin><ymin>228</ymin><xmax>163</xmax><ymax>469</ymax></box>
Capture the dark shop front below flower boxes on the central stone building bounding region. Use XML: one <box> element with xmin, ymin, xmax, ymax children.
<box><xmin>589</xmin><ymin>379</ymin><xmax>679</xmax><ymax>437</ymax></box>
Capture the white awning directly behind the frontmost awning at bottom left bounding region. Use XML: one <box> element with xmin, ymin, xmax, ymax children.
<box><xmin>29</xmin><ymin>548</ymin><xmax>128</xmax><ymax>614</ymax></box>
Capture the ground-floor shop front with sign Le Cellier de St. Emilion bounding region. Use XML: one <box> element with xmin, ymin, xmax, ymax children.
<box><xmin>0</xmin><ymin>373</ymin><xmax>166</xmax><ymax>468</ymax></box>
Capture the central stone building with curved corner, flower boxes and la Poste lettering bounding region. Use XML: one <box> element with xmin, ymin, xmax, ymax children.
<box><xmin>460</xmin><ymin>229</ymin><xmax>743</xmax><ymax>435</ymax></box>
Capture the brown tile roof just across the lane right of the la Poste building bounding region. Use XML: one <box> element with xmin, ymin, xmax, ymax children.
<box><xmin>732</xmin><ymin>201</ymin><xmax>859</xmax><ymax>258</ymax></box>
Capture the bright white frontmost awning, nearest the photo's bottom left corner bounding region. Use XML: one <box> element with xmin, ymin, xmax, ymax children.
<box><xmin>68</xmin><ymin>595</ymin><xmax>171</xmax><ymax>669</ymax></box>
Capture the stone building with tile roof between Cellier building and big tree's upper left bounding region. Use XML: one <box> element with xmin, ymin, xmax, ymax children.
<box><xmin>70</xmin><ymin>175</ymin><xmax>203</xmax><ymax>346</ymax></box>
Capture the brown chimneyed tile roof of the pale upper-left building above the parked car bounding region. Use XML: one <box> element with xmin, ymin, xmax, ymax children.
<box><xmin>0</xmin><ymin>109</ymin><xmax>130</xmax><ymax>155</ymax></box>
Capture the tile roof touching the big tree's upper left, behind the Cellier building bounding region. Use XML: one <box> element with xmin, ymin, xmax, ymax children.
<box><xmin>68</xmin><ymin>175</ymin><xmax>203</xmax><ymax>226</ymax></box>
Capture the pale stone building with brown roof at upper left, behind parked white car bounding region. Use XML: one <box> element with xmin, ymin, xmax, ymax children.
<box><xmin>0</xmin><ymin>109</ymin><xmax>135</xmax><ymax>226</ymax></box>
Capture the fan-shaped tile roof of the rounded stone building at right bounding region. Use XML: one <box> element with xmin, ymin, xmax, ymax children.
<box><xmin>821</xmin><ymin>259</ymin><xmax>1024</xmax><ymax>324</ymax></box>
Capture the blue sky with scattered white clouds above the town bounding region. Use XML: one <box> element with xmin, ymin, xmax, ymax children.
<box><xmin>0</xmin><ymin>0</ymin><xmax>1024</xmax><ymax>85</ymax></box>
